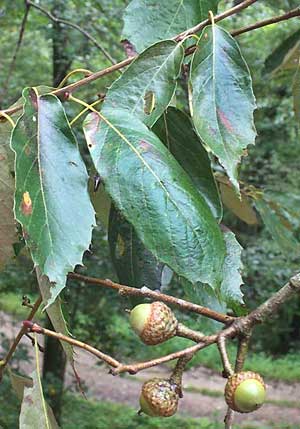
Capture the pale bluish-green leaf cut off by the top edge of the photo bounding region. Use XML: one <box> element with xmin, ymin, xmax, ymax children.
<box><xmin>122</xmin><ymin>0</ymin><xmax>219</xmax><ymax>52</ymax></box>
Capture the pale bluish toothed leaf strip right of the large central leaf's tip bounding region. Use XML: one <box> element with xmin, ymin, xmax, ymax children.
<box><xmin>220</xmin><ymin>231</ymin><xmax>244</xmax><ymax>314</ymax></box>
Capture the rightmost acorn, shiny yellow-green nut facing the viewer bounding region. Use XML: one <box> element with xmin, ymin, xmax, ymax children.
<box><xmin>225</xmin><ymin>371</ymin><xmax>266</xmax><ymax>413</ymax></box>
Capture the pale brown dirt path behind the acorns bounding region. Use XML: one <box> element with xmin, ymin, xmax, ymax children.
<box><xmin>0</xmin><ymin>312</ymin><xmax>300</xmax><ymax>429</ymax></box>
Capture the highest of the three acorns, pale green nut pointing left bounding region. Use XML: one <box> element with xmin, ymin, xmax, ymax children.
<box><xmin>130</xmin><ymin>301</ymin><xmax>178</xmax><ymax>345</ymax></box>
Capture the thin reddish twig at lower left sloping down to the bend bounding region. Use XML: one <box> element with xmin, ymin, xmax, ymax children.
<box><xmin>23</xmin><ymin>320</ymin><xmax>120</xmax><ymax>368</ymax></box>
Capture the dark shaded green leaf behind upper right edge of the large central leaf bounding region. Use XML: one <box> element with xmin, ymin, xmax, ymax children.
<box><xmin>153</xmin><ymin>107</ymin><xmax>223</xmax><ymax>221</ymax></box>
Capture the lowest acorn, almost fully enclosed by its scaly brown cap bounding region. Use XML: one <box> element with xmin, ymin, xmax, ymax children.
<box><xmin>140</xmin><ymin>378</ymin><xmax>179</xmax><ymax>417</ymax></box>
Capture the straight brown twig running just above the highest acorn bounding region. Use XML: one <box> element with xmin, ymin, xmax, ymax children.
<box><xmin>68</xmin><ymin>273</ymin><xmax>235</xmax><ymax>324</ymax></box>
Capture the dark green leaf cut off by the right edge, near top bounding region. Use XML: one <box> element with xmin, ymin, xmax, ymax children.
<box><xmin>264</xmin><ymin>30</ymin><xmax>300</xmax><ymax>73</ymax></box>
